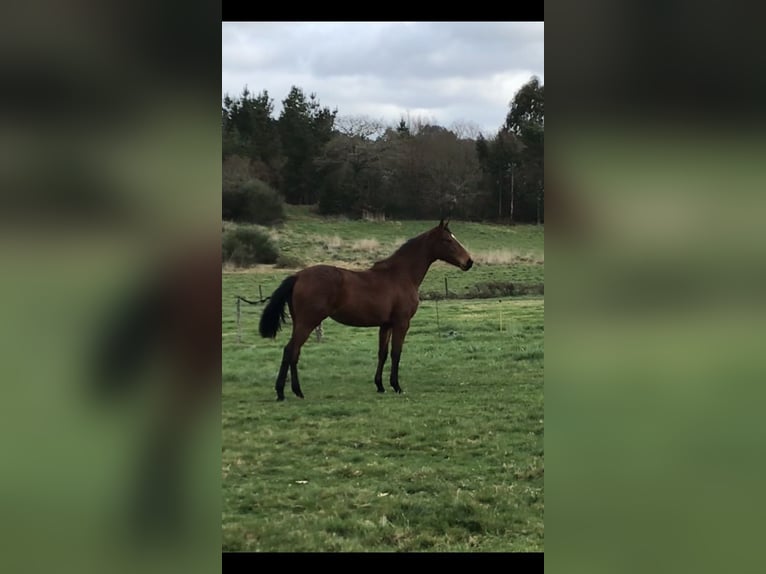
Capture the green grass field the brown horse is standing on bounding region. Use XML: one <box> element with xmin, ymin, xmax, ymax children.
<box><xmin>222</xmin><ymin>209</ymin><xmax>544</xmax><ymax>552</ymax></box>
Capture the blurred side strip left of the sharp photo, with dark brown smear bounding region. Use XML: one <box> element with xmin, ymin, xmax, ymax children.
<box><xmin>0</xmin><ymin>0</ymin><xmax>221</xmax><ymax>572</ymax></box>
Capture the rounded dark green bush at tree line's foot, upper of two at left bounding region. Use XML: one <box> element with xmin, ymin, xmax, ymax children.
<box><xmin>222</xmin><ymin>179</ymin><xmax>285</xmax><ymax>225</ymax></box>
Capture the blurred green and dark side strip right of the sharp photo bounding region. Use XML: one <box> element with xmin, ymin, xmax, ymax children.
<box><xmin>545</xmin><ymin>0</ymin><xmax>766</xmax><ymax>573</ymax></box>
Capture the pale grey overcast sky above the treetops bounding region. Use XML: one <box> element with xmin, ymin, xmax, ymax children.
<box><xmin>221</xmin><ymin>22</ymin><xmax>545</xmax><ymax>135</ymax></box>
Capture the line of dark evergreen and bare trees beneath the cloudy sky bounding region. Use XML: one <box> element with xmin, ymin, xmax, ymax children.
<box><xmin>222</xmin><ymin>77</ymin><xmax>545</xmax><ymax>223</ymax></box>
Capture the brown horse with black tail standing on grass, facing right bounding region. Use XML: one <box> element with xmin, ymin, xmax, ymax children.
<box><xmin>260</xmin><ymin>219</ymin><xmax>473</xmax><ymax>401</ymax></box>
